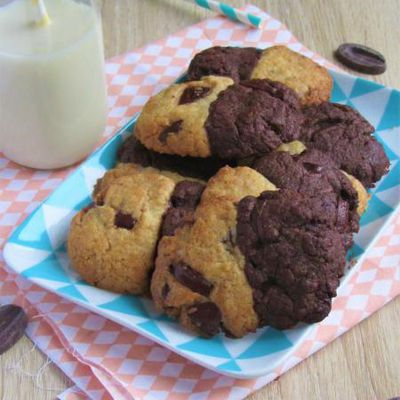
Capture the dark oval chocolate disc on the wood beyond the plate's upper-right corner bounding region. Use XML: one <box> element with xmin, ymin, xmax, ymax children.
<box><xmin>334</xmin><ymin>43</ymin><xmax>386</xmax><ymax>75</ymax></box>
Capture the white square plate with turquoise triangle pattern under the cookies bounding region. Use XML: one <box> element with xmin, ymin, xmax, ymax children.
<box><xmin>4</xmin><ymin>72</ymin><xmax>400</xmax><ymax>378</ymax></box>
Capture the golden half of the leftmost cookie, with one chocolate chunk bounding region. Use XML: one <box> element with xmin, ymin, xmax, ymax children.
<box><xmin>68</xmin><ymin>165</ymin><xmax>179</xmax><ymax>294</ymax></box>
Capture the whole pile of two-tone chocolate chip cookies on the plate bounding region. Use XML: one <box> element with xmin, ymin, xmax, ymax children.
<box><xmin>68</xmin><ymin>46</ymin><xmax>389</xmax><ymax>338</ymax></box>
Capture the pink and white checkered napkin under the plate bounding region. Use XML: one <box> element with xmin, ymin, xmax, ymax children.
<box><xmin>0</xmin><ymin>6</ymin><xmax>400</xmax><ymax>400</ymax></box>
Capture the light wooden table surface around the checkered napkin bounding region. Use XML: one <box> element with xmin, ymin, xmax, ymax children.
<box><xmin>0</xmin><ymin>0</ymin><xmax>400</xmax><ymax>400</ymax></box>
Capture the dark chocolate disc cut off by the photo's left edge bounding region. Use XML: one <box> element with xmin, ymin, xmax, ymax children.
<box><xmin>0</xmin><ymin>304</ymin><xmax>28</xmax><ymax>354</ymax></box>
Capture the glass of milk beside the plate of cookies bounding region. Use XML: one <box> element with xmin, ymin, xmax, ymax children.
<box><xmin>0</xmin><ymin>0</ymin><xmax>107</xmax><ymax>169</ymax></box>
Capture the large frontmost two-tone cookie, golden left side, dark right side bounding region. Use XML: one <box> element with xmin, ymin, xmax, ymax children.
<box><xmin>151</xmin><ymin>167</ymin><xmax>354</xmax><ymax>337</ymax></box>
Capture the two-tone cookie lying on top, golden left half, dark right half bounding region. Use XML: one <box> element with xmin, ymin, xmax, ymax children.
<box><xmin>135</xmin><ymin>76</ymin><xmax>303</xmax><ymax>160</ymax></box>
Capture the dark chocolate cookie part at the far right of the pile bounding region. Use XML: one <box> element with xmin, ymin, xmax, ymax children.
<box><xmin>301</xmin><ymin>102</ymin><xmax>389</xmax><ymax>188</ymax></box>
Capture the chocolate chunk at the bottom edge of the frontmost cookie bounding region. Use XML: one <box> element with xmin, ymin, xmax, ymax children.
<box><xmin>188</xmin><ymin>301</ymin><xmax>222</xmax><ymax>336</ymax></box>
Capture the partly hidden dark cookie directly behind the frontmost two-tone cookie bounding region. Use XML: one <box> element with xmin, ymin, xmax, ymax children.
<box><xmin>253</xmin><ymin>150</ymin><xmax>367</xmax><ymax>248</ymax></box>
